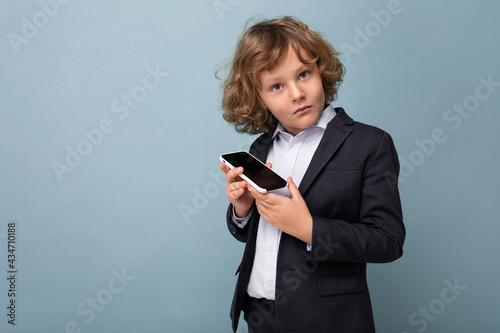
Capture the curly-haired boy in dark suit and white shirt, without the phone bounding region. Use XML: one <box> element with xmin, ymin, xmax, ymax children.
<box><xmin>220</xmin><ymin>17</ymin><xmax>405</xmax><ymax>333</ymax></box>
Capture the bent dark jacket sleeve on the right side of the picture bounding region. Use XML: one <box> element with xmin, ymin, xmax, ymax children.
<box><xmin>302</xmin><ymin>132</ymin><xmax>405</xmax><ymax>263</ymax></box>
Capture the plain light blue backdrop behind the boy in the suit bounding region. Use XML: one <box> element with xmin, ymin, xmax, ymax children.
<box><xmin>0</xmin><ymin>0</ymin><xmax>500</xmax><ymax>333</ymax></box>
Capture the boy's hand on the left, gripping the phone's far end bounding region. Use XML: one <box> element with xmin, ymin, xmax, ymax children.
<box><xmin>219</xmin><ymin>163</ymin><xmax>270</xmax><ymax>217</ymax></box>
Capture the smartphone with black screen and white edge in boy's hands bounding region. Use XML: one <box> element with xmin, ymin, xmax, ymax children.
<box><xmin>219</xmin><ymin>151</ymin><xmax>288</xmax><ymax>193</ymax></box>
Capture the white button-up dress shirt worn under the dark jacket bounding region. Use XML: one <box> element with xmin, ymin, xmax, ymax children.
<box><xmin>233</xmin><ymin>105</ymin><xmax>336</xmax><ymax>300</ymax></box>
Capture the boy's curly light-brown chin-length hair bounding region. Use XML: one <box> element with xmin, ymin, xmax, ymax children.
<box><xmin>222</xmin><ymin>16</ymin><xmax>345</xmax><ymax>134</ymax></box>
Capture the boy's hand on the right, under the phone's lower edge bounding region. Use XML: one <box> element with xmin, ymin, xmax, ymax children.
<box><xmin>248</xmin><ymin>177</ymin><xmax>313</xmax><ymax>244</ymax></box>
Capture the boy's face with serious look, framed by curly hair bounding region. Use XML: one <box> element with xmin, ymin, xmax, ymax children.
<box><xmin>259</xmin><ymin>47</ymin><xmax>325</xmax><ymax>136</ymax></box>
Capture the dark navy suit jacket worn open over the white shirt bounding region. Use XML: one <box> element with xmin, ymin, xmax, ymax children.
<box><xmin>227</xmin><ymin>108</ymin><xmax>405</xmax><ymax>333</ymax></box>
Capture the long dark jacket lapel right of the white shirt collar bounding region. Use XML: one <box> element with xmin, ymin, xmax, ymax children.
<box><xmin>299</xmin><ymin>108</ymin><xmax>354</xmax><ymax>196</ymax></box>
